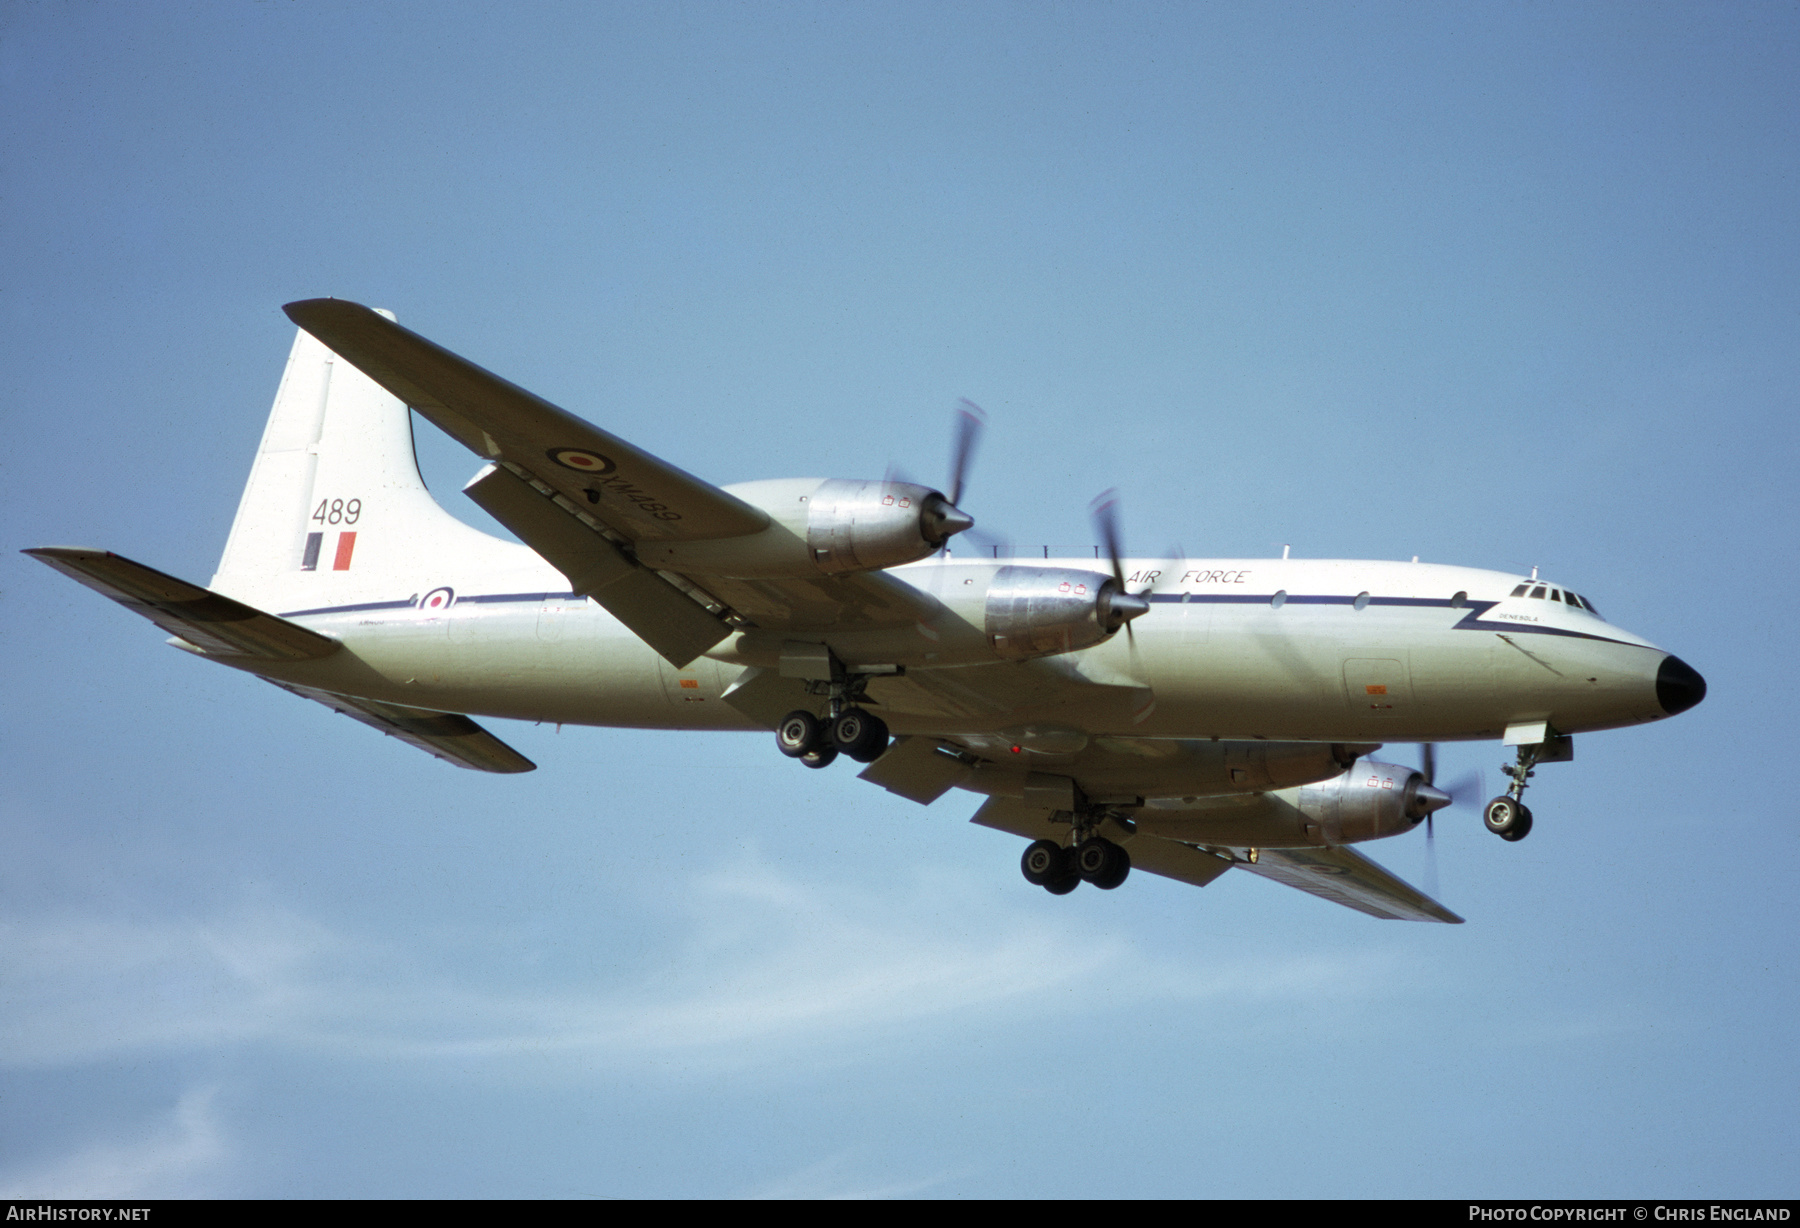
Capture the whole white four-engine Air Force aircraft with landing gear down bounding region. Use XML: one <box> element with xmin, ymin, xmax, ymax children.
<box><xmin>27</xmin><ymin>299</ymin><xmax>1706</xmax><ymax>922</ymax></box>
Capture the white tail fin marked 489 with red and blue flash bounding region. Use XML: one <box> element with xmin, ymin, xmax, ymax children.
<box><xmin>212</xmin><ymin>313</ymin><xmax>520</xmax><ymax>605</ymax></box>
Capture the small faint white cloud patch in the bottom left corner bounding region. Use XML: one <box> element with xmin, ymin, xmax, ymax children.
<box><xmin>0</xmin><ymin>1088</ymin><xmax>227</xmax><ymax>1199</ymax></box>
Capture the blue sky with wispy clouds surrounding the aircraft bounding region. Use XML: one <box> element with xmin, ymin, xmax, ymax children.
<box><xmin>0</xmin><ymin>4</ymin><xmax>1800</xmax><ymax>1197</ymax></box>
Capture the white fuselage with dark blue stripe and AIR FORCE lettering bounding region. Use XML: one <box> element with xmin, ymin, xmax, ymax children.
<box><xmin>221</xmin><ymin>547</ymin><xmax>1667</xmax><ymax>742</ymax></box>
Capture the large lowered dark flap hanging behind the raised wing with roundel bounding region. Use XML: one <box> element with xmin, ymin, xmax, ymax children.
<box><xmin>464</xmin><ymin>466</ymin><xmax>731</xmax><ymax>668</ymax></box>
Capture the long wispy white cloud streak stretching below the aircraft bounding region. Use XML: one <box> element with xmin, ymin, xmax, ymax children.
<box><xmin>0</xmin><ymin>849</ymin><xmax>1399</xmax><ymax>1070</ymax></box>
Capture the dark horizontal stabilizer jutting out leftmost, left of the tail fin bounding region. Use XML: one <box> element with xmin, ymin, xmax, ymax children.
<box><xmin>25</xmin><ymin>546</ymin><xmax>338</xmax><ymax>661</ymax></box>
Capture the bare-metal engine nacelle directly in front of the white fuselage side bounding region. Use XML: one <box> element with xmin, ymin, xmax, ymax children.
<box><xmin>985</xmin><ymin>567</ymin><xmax>1150</xmax><ymax>661</ymax></box>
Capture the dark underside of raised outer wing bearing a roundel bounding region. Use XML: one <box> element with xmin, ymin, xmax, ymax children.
<box><xmin>283</xmin><ymin>299</ymin><xmax>769</xmax><ymax>542</ymax></box>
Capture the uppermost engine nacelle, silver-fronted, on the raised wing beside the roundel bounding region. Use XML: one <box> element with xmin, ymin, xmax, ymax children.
<box><xmin>637</xmin><ymin>477</ymin><xmax>974</xmax><ymax>580</ymax></box>
